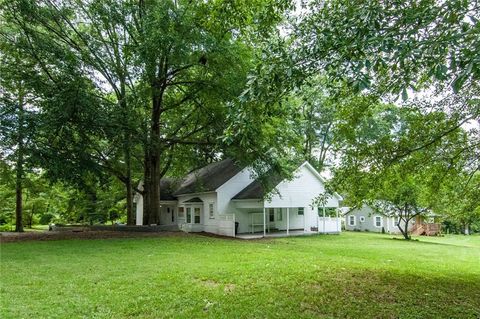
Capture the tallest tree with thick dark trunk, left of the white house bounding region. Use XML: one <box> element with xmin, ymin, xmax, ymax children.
<box><xmin>4</xmin><ymin>0</ymin><xmax>287</xmax><ymax>223</ymax></box>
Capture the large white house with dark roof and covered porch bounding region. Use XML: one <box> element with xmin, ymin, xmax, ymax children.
<box><xmin>134</xmin><ymin>159</ymin><xmax>342</xmax><ymax>236</ymax></box>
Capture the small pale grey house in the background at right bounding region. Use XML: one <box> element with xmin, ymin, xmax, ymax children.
<box><xmin>343</xmin><ymin>204</ymin><xmax>415</xmax><ymax>234</ymax></box>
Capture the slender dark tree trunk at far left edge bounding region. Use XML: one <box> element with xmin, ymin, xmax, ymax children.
<box><xmin>15</xmin><ymin>84</ymin><xmax>25</xmax><ymax>232</ymax></box>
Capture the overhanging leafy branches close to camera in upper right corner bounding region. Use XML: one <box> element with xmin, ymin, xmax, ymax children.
<box><xmin>249</xmin><ymin>0</ymin><xmax>480</xmax><ymax>180</ymax></box>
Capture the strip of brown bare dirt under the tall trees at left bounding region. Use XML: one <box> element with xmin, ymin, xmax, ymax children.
<box><xmin>0</xmin><ymin>230</ymin><xmax>189</xmax><ymax>243</ymax></box>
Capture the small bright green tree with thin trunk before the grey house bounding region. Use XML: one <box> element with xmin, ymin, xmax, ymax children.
<box><xmin>334</xmin><ymin>104</ymin><xmax>470</xmax><ymax>239</ymax></box>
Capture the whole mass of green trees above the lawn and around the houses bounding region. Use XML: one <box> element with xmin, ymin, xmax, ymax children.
<box><xmin>0</xmin><ymin>0</ymin><xmax>480</xmax><ymax>237</ymax></box>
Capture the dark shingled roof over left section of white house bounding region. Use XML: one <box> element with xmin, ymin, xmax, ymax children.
<box><xmin>173</xmin><ymin>158</ymin><xmax>243</xmax><ymax>196</ymax></box>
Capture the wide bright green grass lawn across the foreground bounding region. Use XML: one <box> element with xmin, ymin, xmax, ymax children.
<box><xmin>0</xmin><ymin>233</ymin><xmax>480</xmax><ymax>318</ymax></box>
